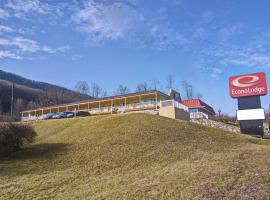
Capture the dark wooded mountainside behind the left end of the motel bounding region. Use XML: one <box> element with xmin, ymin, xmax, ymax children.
<box><xmin>0</xmin><ymin>70</ymin><xmax>91</xmax><ymax>118</ymax></box>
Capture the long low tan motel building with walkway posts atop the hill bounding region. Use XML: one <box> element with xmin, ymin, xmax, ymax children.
<box><xmin>22</xmin><ymin>90</ymin><xmax>215</xmax><ymax>121</ymax></box>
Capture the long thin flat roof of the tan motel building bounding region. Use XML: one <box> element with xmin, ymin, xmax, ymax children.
<box><xmin>22</xmin><ymin>90</ymin><xmax>170</xmax><ymax>112</ymax></box>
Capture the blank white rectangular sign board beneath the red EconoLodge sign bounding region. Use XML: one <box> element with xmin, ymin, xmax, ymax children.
<box><xmin>237</xmin><ymin>108</ymin><xmax>265</xmax><ymax>120</ymax></box>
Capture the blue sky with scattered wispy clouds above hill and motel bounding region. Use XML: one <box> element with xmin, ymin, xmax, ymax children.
<box><xmin>0</xmin><ymin>0</ymin><xmax>270</xmax><ymax>115</ymax></box>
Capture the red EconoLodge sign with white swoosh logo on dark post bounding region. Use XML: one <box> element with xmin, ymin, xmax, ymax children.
<box><xmin>229</xmin><ymin>72</ymin><xmax>267</xmax><ymax>98</ymax></box>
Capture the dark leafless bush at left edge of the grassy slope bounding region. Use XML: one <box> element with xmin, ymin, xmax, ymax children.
<box><xmin>0</xmin><ymin>123</ymin><xmax>37</xmax><ymax>155</ymax></box>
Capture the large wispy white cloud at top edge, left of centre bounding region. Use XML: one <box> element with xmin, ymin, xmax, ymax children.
<box><xmin>72</xmin><ymin>0</ymin><xmax>144</xmax><ymax>41</ymax></box>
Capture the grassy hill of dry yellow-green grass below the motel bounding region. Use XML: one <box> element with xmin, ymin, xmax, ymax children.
<box><xmin>0</xmin><ymin>114</ymin><xmax>270</xmax><ymax>199</ymax></box>
